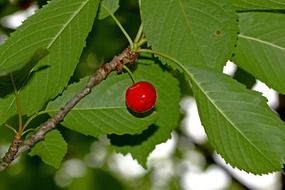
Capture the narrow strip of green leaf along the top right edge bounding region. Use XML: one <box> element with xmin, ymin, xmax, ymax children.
<box><xmin>232</xmin><ymin>0</ymin><xmax>285</xmax><ymax>11</ymax></box>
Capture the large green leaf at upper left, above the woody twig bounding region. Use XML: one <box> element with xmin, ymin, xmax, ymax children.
<box><xmin>0</xmin><ymin>0</ymin><xmax>99</xmax><ymax>124</ymax></box>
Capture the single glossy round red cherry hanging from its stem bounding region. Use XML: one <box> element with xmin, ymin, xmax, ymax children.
<box><xmin>126</xmin><ymin>81</ymin><xmax>156</xmax><ymax>113</ymax></box>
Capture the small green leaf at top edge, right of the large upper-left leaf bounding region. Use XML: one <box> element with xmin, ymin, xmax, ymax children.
<box><xmin>98</xmin><ymin>0</ymin><xmax>120</xmax><ymax>20</ymax></box>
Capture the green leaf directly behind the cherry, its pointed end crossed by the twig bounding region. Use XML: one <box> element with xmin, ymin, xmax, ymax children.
<box><xmin>46</xmin><ymin>74</ymin><xmax>158</xmax><ymax>137</ymax></box>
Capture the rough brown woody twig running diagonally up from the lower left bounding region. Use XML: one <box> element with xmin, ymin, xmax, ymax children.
<box><xmin>0</xmin><ymin>48</ymin><xmax>138</xmax><ymax>172</ymax></box>
